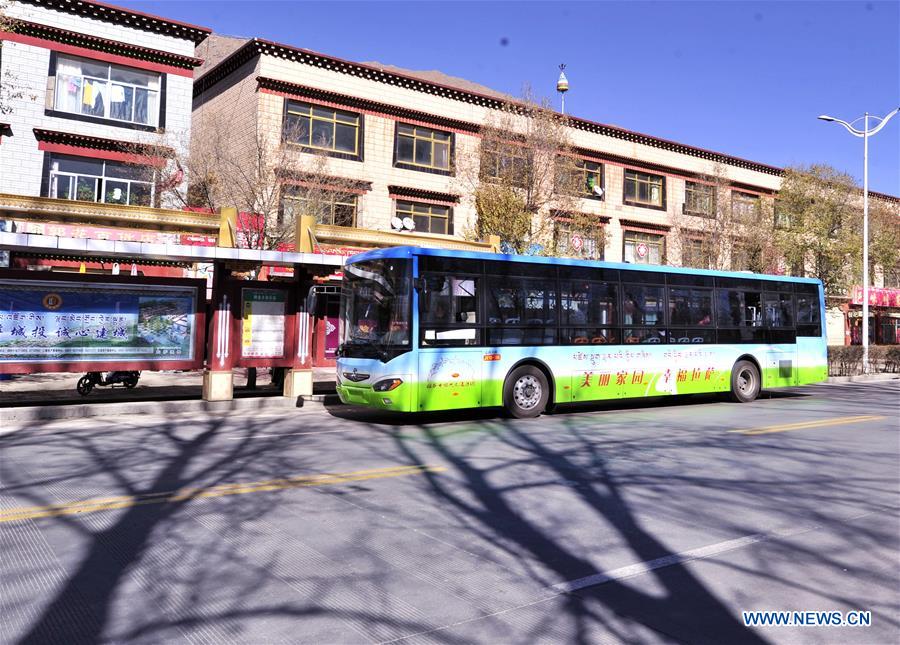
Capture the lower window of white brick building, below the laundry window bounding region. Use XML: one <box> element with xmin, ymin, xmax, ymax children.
<box><xmin>48</xmin><ymin>155</ymin><xmax>154</xmax><ymax>206</ymax></box>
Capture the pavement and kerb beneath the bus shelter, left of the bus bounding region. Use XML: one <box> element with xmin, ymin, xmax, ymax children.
<box><xmin>0</xmin><ymin>367</ymin><xmax>335</xmax><ymax>422</ymax></box>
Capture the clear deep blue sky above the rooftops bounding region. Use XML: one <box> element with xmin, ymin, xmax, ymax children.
<box><xmin>130</xmin><ymin>0</ymin><xmax>900</xmax><ymax>195</ymax></box>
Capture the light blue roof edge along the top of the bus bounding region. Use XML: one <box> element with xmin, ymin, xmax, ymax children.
<box><xmin>347</xmin><ymin>246</ymin><xmax>821</xmax><ymax>284</ymax></box>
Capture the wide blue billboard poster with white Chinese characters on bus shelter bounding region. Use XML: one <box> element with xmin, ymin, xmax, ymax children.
<box><xmin>0</xmin><ymin>281</ymin><xmax>197</xmax><ymax>363</ymax></box>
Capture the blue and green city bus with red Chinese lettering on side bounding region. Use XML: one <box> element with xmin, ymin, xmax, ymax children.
<box><xmin>337</xmin><ymin>247</ymin><xmax>828</xmax><ymax>418</ymax></box>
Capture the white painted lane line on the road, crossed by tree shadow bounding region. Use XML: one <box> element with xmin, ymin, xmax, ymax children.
<box><xmin>551</xmin><ymin>511</ymin><xmax>874</xmax><ymax>593</ymax></box>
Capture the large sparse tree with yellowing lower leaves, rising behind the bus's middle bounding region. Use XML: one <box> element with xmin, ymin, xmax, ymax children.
<box><xmin>457</xmin><ymin>92</ymin><xmax>602</xmax><ymax>253</ymax></box>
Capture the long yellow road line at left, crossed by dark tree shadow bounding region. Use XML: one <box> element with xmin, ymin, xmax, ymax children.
<box><xmin>0</xmin><ymin>465</ymin><xmax>447</xmax><ymax>523</ymax></box>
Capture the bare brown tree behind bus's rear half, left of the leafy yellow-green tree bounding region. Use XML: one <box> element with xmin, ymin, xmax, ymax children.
<box><xmin>675</xmin><ymin>164</ymin><xmax>779</xmax><ymax>272</ymax></box>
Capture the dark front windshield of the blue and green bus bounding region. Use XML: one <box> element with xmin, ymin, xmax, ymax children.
<box><xmin>340</xmin><ymin>258</ymin><xmax>412</xmax><ymax>360</ymax></box>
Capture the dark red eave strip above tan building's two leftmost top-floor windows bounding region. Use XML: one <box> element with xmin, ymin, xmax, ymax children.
<box><xmin>256</xmin><ymin>76</ymin><xmax>481</xmax><ymax>134</ymax></box>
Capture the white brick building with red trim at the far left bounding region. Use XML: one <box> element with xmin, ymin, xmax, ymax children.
<box><xmin>0</xmin><ymin>0</ymin><xmax>210</xmax><ymax>207</ymax></box>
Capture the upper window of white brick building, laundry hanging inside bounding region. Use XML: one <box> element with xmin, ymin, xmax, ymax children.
<box><xmin>54</xmin><ymin>56</ymin><xmax>161</xmax><ymax>126</ymax></box>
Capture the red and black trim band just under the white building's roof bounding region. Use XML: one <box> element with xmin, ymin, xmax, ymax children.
<box><xmin>0</xmin><ymin>21</ymin><xmax>203</xmax><ymax>77</ymax></box>
